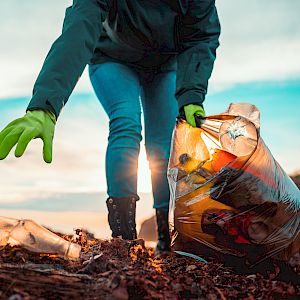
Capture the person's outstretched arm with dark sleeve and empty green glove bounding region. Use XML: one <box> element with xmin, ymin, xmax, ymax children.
<box><xmin>0</xmin><ymin>0</ymin><xmax>110</xmax><ymax>163</ymax></box>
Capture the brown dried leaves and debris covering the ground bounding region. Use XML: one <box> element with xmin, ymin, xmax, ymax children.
<box><xmin>0</xmin><ymin>232</ymin><xmax>300</xmax><ymax>300</ymax></box>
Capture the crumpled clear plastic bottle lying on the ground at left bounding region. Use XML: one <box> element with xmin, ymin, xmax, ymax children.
<box><xmin>0</xmin><ymin>217</ymin><xmax>81</xmax><ymax>259</ymax></box>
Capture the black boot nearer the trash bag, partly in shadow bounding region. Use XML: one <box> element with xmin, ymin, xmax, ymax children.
<box><xmin>155</xmin><ymin>208</ymin><xmax>171</xmax><ymax>254</ymax></box>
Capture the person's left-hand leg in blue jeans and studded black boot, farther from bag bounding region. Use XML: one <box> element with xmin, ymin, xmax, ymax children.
<box><xmin>89</xmin><ymin>63</ymin><xmax>142</xmax><ymax>239</ymax></box>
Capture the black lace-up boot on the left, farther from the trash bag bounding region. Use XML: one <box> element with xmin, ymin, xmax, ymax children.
<box><xmin>106</xmin><ymin>196</ymin><xmax>139</xmax><ymax>240</ymax></box>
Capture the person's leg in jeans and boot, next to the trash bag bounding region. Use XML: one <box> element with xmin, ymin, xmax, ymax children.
<box><xmin>142</xmin><ymin>71</ymin><xmax>178</xmax><ymax>253</ymax></box>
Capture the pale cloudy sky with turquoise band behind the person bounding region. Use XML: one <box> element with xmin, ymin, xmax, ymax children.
<box><xmin>0</xmin><ymin>0</ymin><xmax>300</xmax><ymax>235</ymax></box>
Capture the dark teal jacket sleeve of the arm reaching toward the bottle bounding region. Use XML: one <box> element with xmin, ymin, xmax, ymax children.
<box><xmin>27</xmin><ymin>0</ymin><xmax>110</xmax><ymax>118</ymax></box>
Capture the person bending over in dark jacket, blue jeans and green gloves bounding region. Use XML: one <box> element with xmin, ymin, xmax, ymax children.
<box><xmin>0</xmin><ymin>0</ymin><xmax>220</xmax><ymax>253</ymax></box>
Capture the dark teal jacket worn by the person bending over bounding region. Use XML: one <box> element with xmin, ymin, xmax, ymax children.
<box><xmin>27</xmin><ymin>0</ymin><xmax>220</xmax><ymax>117</ymax></box>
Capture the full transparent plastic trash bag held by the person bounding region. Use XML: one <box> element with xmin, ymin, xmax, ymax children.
<box><xmin>168</xmin><ymin>103</ymin><xmax>300</xmax><ymax>266</ymax></box>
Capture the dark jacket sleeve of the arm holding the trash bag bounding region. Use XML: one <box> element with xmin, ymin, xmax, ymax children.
<box><xmin>175</xmin><ymin>0</ymin><xmax>220</xmax><ymax>109</ymax></box>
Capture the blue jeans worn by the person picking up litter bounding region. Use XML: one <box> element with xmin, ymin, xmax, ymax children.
<box><xmin>89</xmin><ymin>62</ymin><xmax>178</xmax><ymax>209</ymax></box>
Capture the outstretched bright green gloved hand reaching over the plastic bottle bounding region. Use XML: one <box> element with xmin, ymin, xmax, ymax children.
<box><xmin>0</xmin><ymin>110</ymin><xmax>56</xmax><ymax>163</ymax></box>
